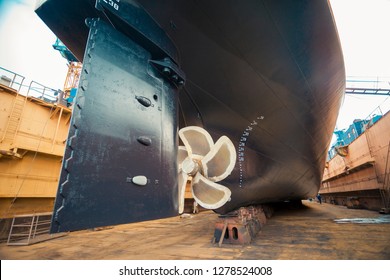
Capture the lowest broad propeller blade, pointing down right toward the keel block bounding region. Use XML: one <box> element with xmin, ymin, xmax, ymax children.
<box><xmin>192</xmin><ymin>173</ymin><xmax>231</xmax><ymax>209</ymax></box>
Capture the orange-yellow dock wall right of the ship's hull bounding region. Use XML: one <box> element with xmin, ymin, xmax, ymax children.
<box><xmin>320</xmin><ymin>113</ymin><xmax>390</xmax><ymax>210</ymax></box>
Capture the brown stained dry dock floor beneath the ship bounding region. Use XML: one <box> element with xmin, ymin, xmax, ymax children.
<box><xmin>0</xmin><ymin>201</ymin><xmax>390</xmax><ymax>260</ymax></box>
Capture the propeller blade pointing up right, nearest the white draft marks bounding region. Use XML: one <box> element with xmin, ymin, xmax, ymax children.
<box><xmin>201</xmin><ymin>136</ymin><xmax>237</xmax><ymax>182</ymax></box>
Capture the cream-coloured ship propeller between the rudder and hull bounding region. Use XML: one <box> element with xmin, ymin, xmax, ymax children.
<box><xmin>178</xmin><ymin>126</ymin><xmax>237</xmax><ymax>213</ymax></box>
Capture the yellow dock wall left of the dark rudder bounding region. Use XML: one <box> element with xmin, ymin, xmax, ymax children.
<box><xmin>0</xmin><ymin>84</ymin><xmax>71</xmax><ymax>218</ymax></box>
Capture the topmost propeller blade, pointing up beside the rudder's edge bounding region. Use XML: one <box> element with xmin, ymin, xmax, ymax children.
<box><xmin>179</xmin><ymin>126</ymin><xmax>214</xmax><ymax>158</ymax></box>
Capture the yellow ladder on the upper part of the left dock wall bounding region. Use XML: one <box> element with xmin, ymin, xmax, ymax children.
<box><xmin>0</xmin><ymin>93</ymin><xmax>27</xmax><ymax>147</ymax></box>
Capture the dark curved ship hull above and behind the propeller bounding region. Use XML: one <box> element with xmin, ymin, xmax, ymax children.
<box><xmin>37</xmin><ymin>0</ymin><xmax>345</xmax><ymax>213</ymax></box>
